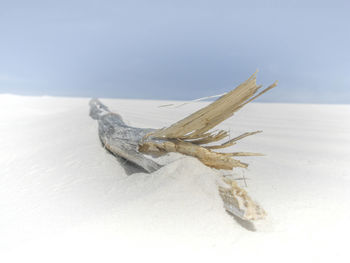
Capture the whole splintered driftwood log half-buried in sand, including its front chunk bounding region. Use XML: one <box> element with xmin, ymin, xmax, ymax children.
<box><xmin>90</xmin><ymin>74</ymin><xmax>277</xmax><ymax>223</ymax></box>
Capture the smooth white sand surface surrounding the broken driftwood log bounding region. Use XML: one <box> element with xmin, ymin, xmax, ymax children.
<box><xmin>0</xmin><ymin>95</ymin><xmax>350</xmax><ymax>262</ymax></box>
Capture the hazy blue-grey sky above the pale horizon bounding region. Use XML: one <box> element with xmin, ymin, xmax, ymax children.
<box><xmin>0</xmin><ymin>0</ymin><xmax>350</xmax><ymax>104</ymax></box>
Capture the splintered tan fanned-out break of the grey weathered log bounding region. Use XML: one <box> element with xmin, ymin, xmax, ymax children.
<box><xmin>138</xmin><ymin>73</ymin><xmax>277</xmax><ymax>170</ymax></box>
